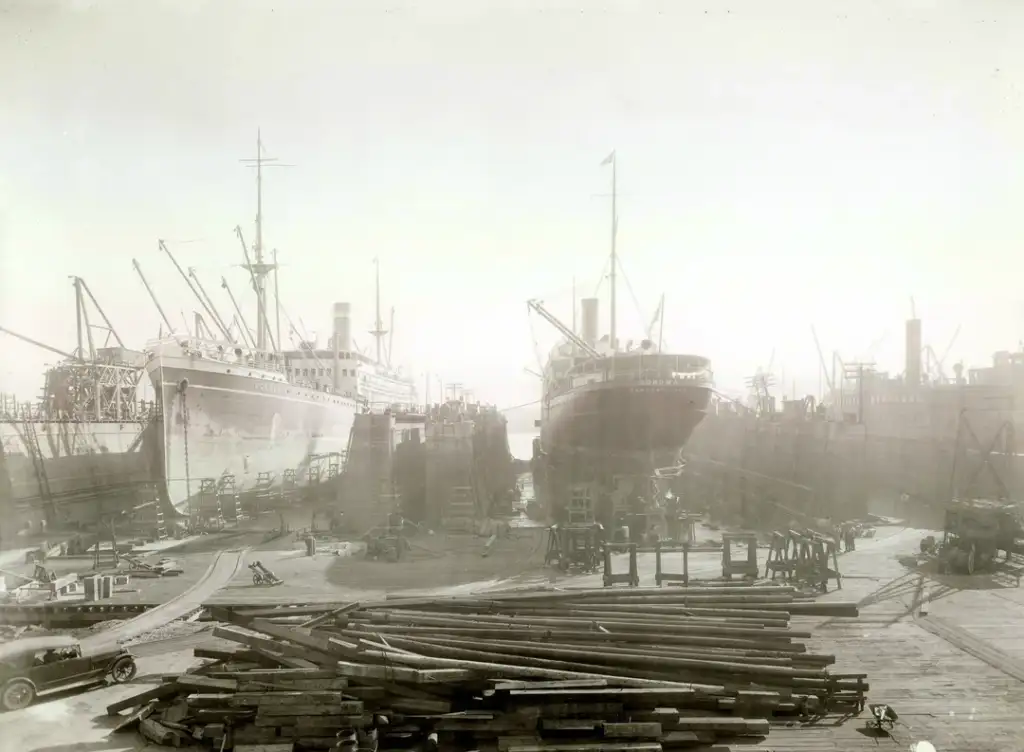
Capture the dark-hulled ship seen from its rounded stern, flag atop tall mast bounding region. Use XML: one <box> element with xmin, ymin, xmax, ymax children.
<box><xmin>530</xmin><ymin>154</ymin><xmax>713</xmax><ymax>462</ymax></box>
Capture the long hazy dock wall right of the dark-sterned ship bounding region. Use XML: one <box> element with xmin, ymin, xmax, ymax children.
<box><xmin>683</xmin><ymin>401</ymin><xmax>1024</xmax><ymax>528</ymax></box>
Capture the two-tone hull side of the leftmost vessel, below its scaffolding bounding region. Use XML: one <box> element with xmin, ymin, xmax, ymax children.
<box><xmin>0</xmin><ymin>420</ymin><xmax>159</xmax><ymax>528</ymax></box>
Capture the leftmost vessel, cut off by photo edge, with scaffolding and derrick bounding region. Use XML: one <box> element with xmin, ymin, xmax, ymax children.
<box><xmin>0</xmin><ymin>277</ymin><xmax>159</xmax><ymax>539</ymax></box>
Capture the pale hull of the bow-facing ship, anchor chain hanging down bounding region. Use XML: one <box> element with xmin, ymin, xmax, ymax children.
<box><xmin>146</xmin><ymin>356</ymin><xmax>357</xmax><ymax>514</ymax></box>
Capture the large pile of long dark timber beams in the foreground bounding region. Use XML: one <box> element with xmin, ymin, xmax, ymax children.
<box><xmin>108</xmin><ymin>584</ymin><xmax>867</xmax><ymax>752</ymax></box>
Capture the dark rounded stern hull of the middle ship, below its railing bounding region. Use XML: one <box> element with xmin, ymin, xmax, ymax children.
<box><xmin>541</xmin><ymin>380</ymin><xmax>712</xmax><ymax>456</ymax></box>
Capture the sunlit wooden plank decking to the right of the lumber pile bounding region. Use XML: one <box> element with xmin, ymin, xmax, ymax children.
<box><xmin>751</xmin><ymin>531</ymin><xmax>1024</xmax><ymax>752</ymax></box>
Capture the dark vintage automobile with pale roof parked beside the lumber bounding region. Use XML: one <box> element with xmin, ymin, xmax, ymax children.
<box><xmin>0</xmin><ymin>635</ymin><xmax>137</xmax><ymax>710</ymax></box>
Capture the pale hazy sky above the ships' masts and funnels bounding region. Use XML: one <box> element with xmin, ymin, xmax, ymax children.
<box><xmin>0</xmin><ymin>0</ymin><xmax>1024</xmax><ymax>405</ymax></box>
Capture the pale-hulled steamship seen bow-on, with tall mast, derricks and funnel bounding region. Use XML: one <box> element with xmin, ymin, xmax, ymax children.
<box><xmin>145</xmin><ymin>135</ymin><xmax>417</xmax><ymax>514</ymax></box>
